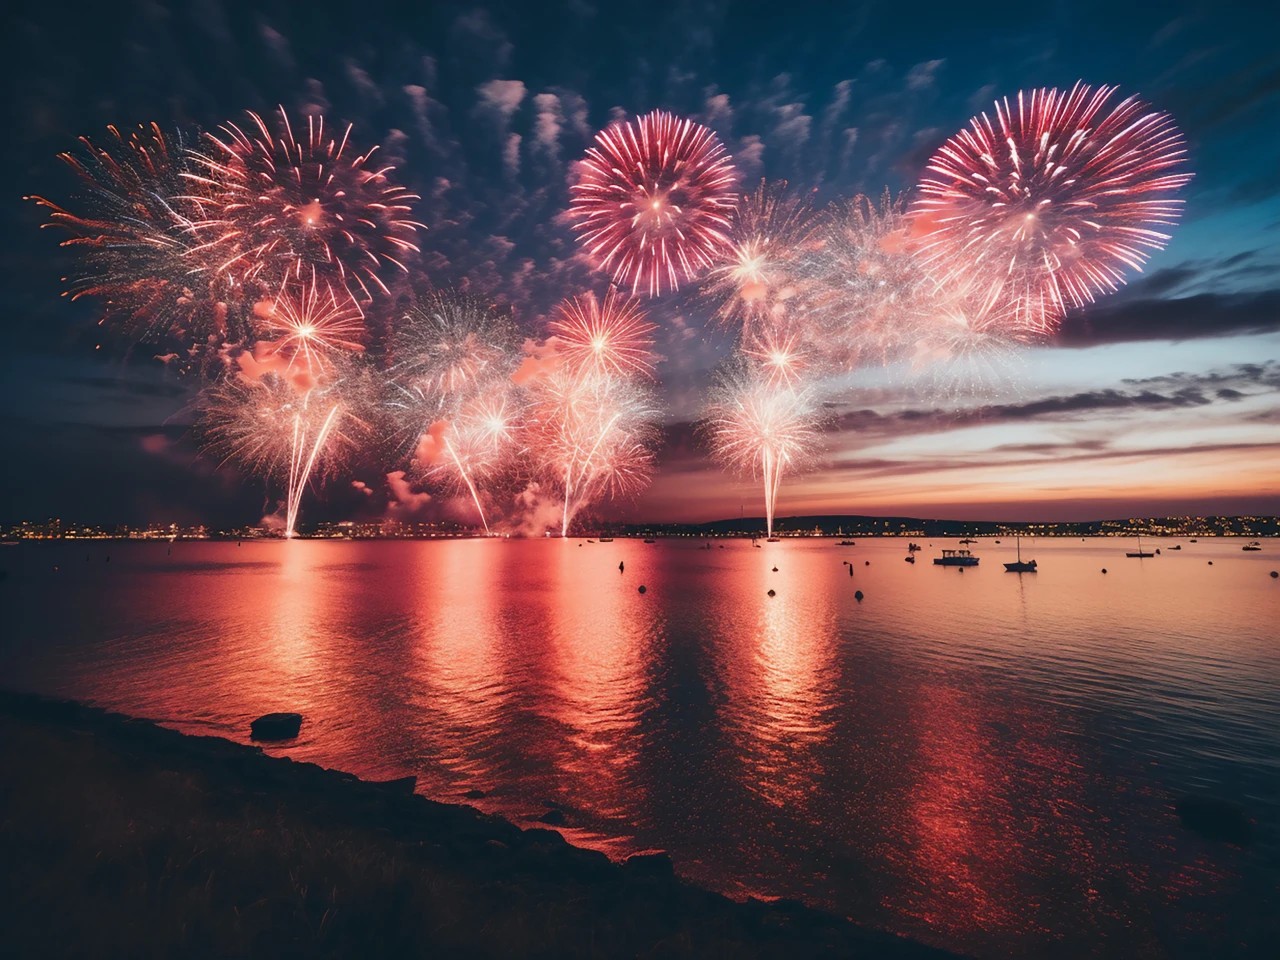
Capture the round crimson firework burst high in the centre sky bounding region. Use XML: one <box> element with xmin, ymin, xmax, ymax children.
<box><xmin>570</xmin><ymin>110</ymin><xmax>737</xmax><ymax>297</ymax></box>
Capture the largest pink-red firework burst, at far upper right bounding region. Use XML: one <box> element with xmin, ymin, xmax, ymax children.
<box><xmin>911</xmin><ymin>83</ymin><xmax>1192</xmax><ymax>333</ymax></box>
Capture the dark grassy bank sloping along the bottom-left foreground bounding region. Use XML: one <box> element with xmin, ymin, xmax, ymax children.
<box><xmin>0</xmin><ymin>692</ymin><xmax>948</xmax><ymax>960</ymax></box>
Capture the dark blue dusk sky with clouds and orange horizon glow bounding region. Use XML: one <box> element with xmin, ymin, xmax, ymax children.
<box><xmin>0</xmin><ymin>0</ymin><xmax>1280</xmax><ymax>525</ymax></box>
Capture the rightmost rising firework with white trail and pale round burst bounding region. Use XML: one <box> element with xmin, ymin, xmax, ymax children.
<box><xmin>700</xmin><ymin>366</ymin><xmax>822</xmax><ymax>538</ymax></box>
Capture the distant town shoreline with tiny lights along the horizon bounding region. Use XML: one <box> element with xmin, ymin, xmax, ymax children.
<box><xmin>0</xmin><ymin>515</ymin><xmax>1280</xmax><ymax>543</ymax></box>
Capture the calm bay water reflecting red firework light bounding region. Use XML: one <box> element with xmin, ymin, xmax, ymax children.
<box><xmin>0</xmin><ymin>538</ymin><xmax>1280</xmax><ymax>957</ymax></box>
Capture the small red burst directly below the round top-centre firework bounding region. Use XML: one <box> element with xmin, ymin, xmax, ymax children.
<box><xmin>550</xmin><ymin>287</ymin><xmax>657</xmax><ymax>376</ymax></box>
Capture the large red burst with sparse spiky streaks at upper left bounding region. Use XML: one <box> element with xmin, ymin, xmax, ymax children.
<box><xmin>186</xmin><ymin>108</ymin><xmax>422</xmax><ymax>302</ymax></box>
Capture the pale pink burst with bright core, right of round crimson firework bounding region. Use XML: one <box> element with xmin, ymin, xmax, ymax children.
<box><xmin>703</xmin><ymin>180</ymin><xmax>818</xmax><ymax>333</ymax></box>
